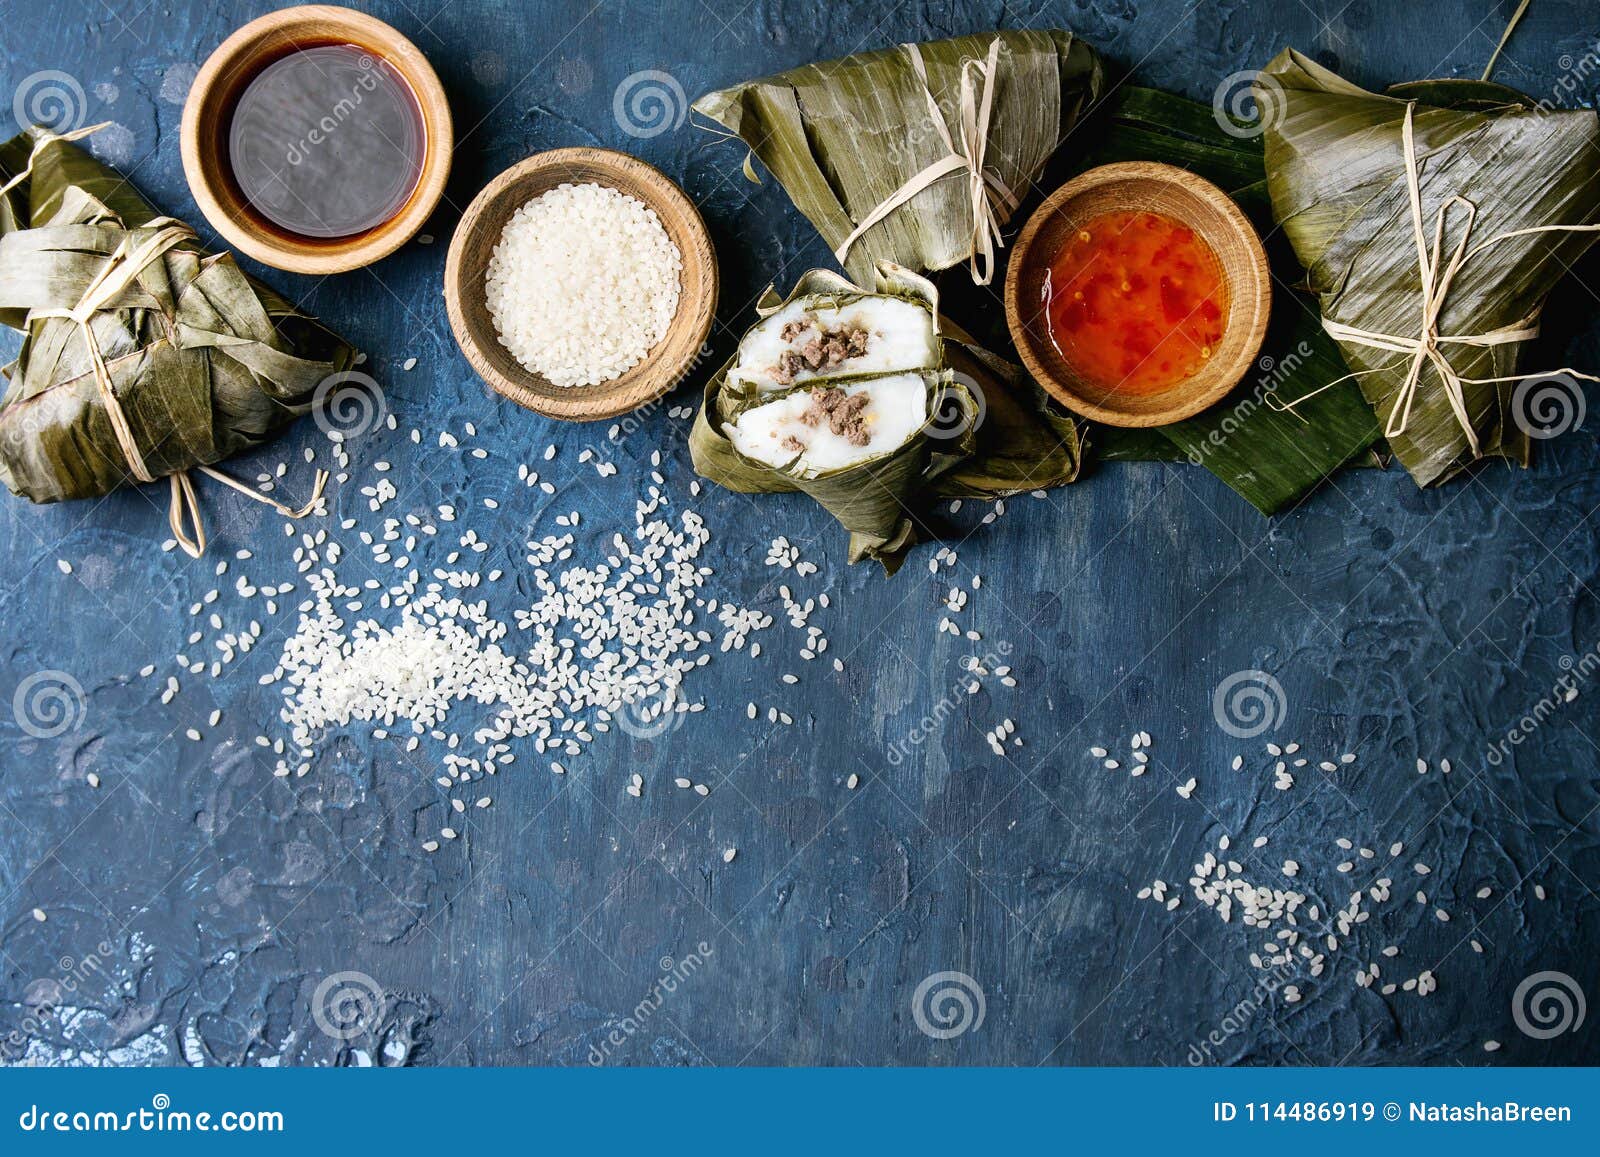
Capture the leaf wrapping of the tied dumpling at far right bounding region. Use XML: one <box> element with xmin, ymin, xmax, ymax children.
<box><xmin>1256</xmin><ymin>50</ymin><xmax>1600</xmax><ymax>486</ymax></box>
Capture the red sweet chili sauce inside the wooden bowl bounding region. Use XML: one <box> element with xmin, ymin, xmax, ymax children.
<box><xmin>1045</xmin><ymin>210</ymin><xmax>1227</xmax><ymax>394</ymax></box>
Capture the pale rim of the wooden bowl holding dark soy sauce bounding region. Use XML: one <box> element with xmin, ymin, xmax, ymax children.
<box><xmin>179</xmin><ymin>5</ymin><xmax>454</xmax><ymax>274</ymax></box>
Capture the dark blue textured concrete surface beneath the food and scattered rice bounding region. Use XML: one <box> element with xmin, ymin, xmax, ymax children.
<box><xmin>0</xmin><ymin>0</ymin><xmax>1600</xmax><ymax>1064</ymax></box>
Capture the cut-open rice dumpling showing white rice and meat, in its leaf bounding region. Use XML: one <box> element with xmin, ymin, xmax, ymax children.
<box><xmin>690</xmin><ymin>264</ymin><xmax>1078</xmax><ymax>574</ymax></box>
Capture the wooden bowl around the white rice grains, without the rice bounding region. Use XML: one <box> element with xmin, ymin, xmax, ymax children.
<box><xmin>445</xmin><ymin>147</ymin><xmax>717</xmax><ymax>421</ymax></box>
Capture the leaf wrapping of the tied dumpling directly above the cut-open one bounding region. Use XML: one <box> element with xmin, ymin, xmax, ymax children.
<box><xmin>694</xmin><ymin>29</ymin><xmax>1101</xmax><ymax>285</ymax></box>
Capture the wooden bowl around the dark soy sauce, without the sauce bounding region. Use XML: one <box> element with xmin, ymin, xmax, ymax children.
<box><xmin>181</xmin><ymin>5</ymin><xmax>454</xmax><ymax>274</ymax></box>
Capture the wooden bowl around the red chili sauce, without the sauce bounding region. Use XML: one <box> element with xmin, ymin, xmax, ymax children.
<box><xmin>1005</xmin><ymin>162</ymin><xmax>1272</xmax><ymax>426</ymax></box>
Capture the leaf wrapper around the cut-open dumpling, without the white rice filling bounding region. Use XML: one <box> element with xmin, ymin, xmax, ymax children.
<box><xmin>690</xmin><ymin>264</ymin><xmax>1080</xmax><ymax>574</ymax></box>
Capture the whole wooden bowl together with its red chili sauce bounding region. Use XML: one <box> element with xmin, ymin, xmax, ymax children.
<box><xmin>1005</xmin><ymin>162</ymin><xmax>1272</xmax><ymax>426</ymax></box>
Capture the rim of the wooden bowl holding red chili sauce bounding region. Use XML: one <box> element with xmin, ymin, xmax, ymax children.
<box><xmin>1005</xmin><ymin>160</ymin><xmax>1272</xmax><ymax>427</ymax></box>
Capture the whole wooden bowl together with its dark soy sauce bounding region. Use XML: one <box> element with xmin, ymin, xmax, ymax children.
<box><xmin>182</xmin><ymin>5</ymin><xmax>454</xmax><ymax>274</ymax></box>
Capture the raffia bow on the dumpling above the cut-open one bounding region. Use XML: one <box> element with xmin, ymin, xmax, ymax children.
<box><xmin>834</xmin><ymin>37</ymin><xmax>1018</xmax><ymax>285</ymax></box>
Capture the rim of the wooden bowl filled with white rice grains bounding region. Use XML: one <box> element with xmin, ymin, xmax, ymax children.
<box><xmin>445</xmin><ymin>146</ymin><xmax>720</xmax><ymax>421</ymax></box>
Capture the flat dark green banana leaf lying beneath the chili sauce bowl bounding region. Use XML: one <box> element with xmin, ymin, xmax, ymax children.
<box><xmin>1080</xmin><ymin>85</ymin><xmax>1379</xmax><ymax>515</ymax></box>
